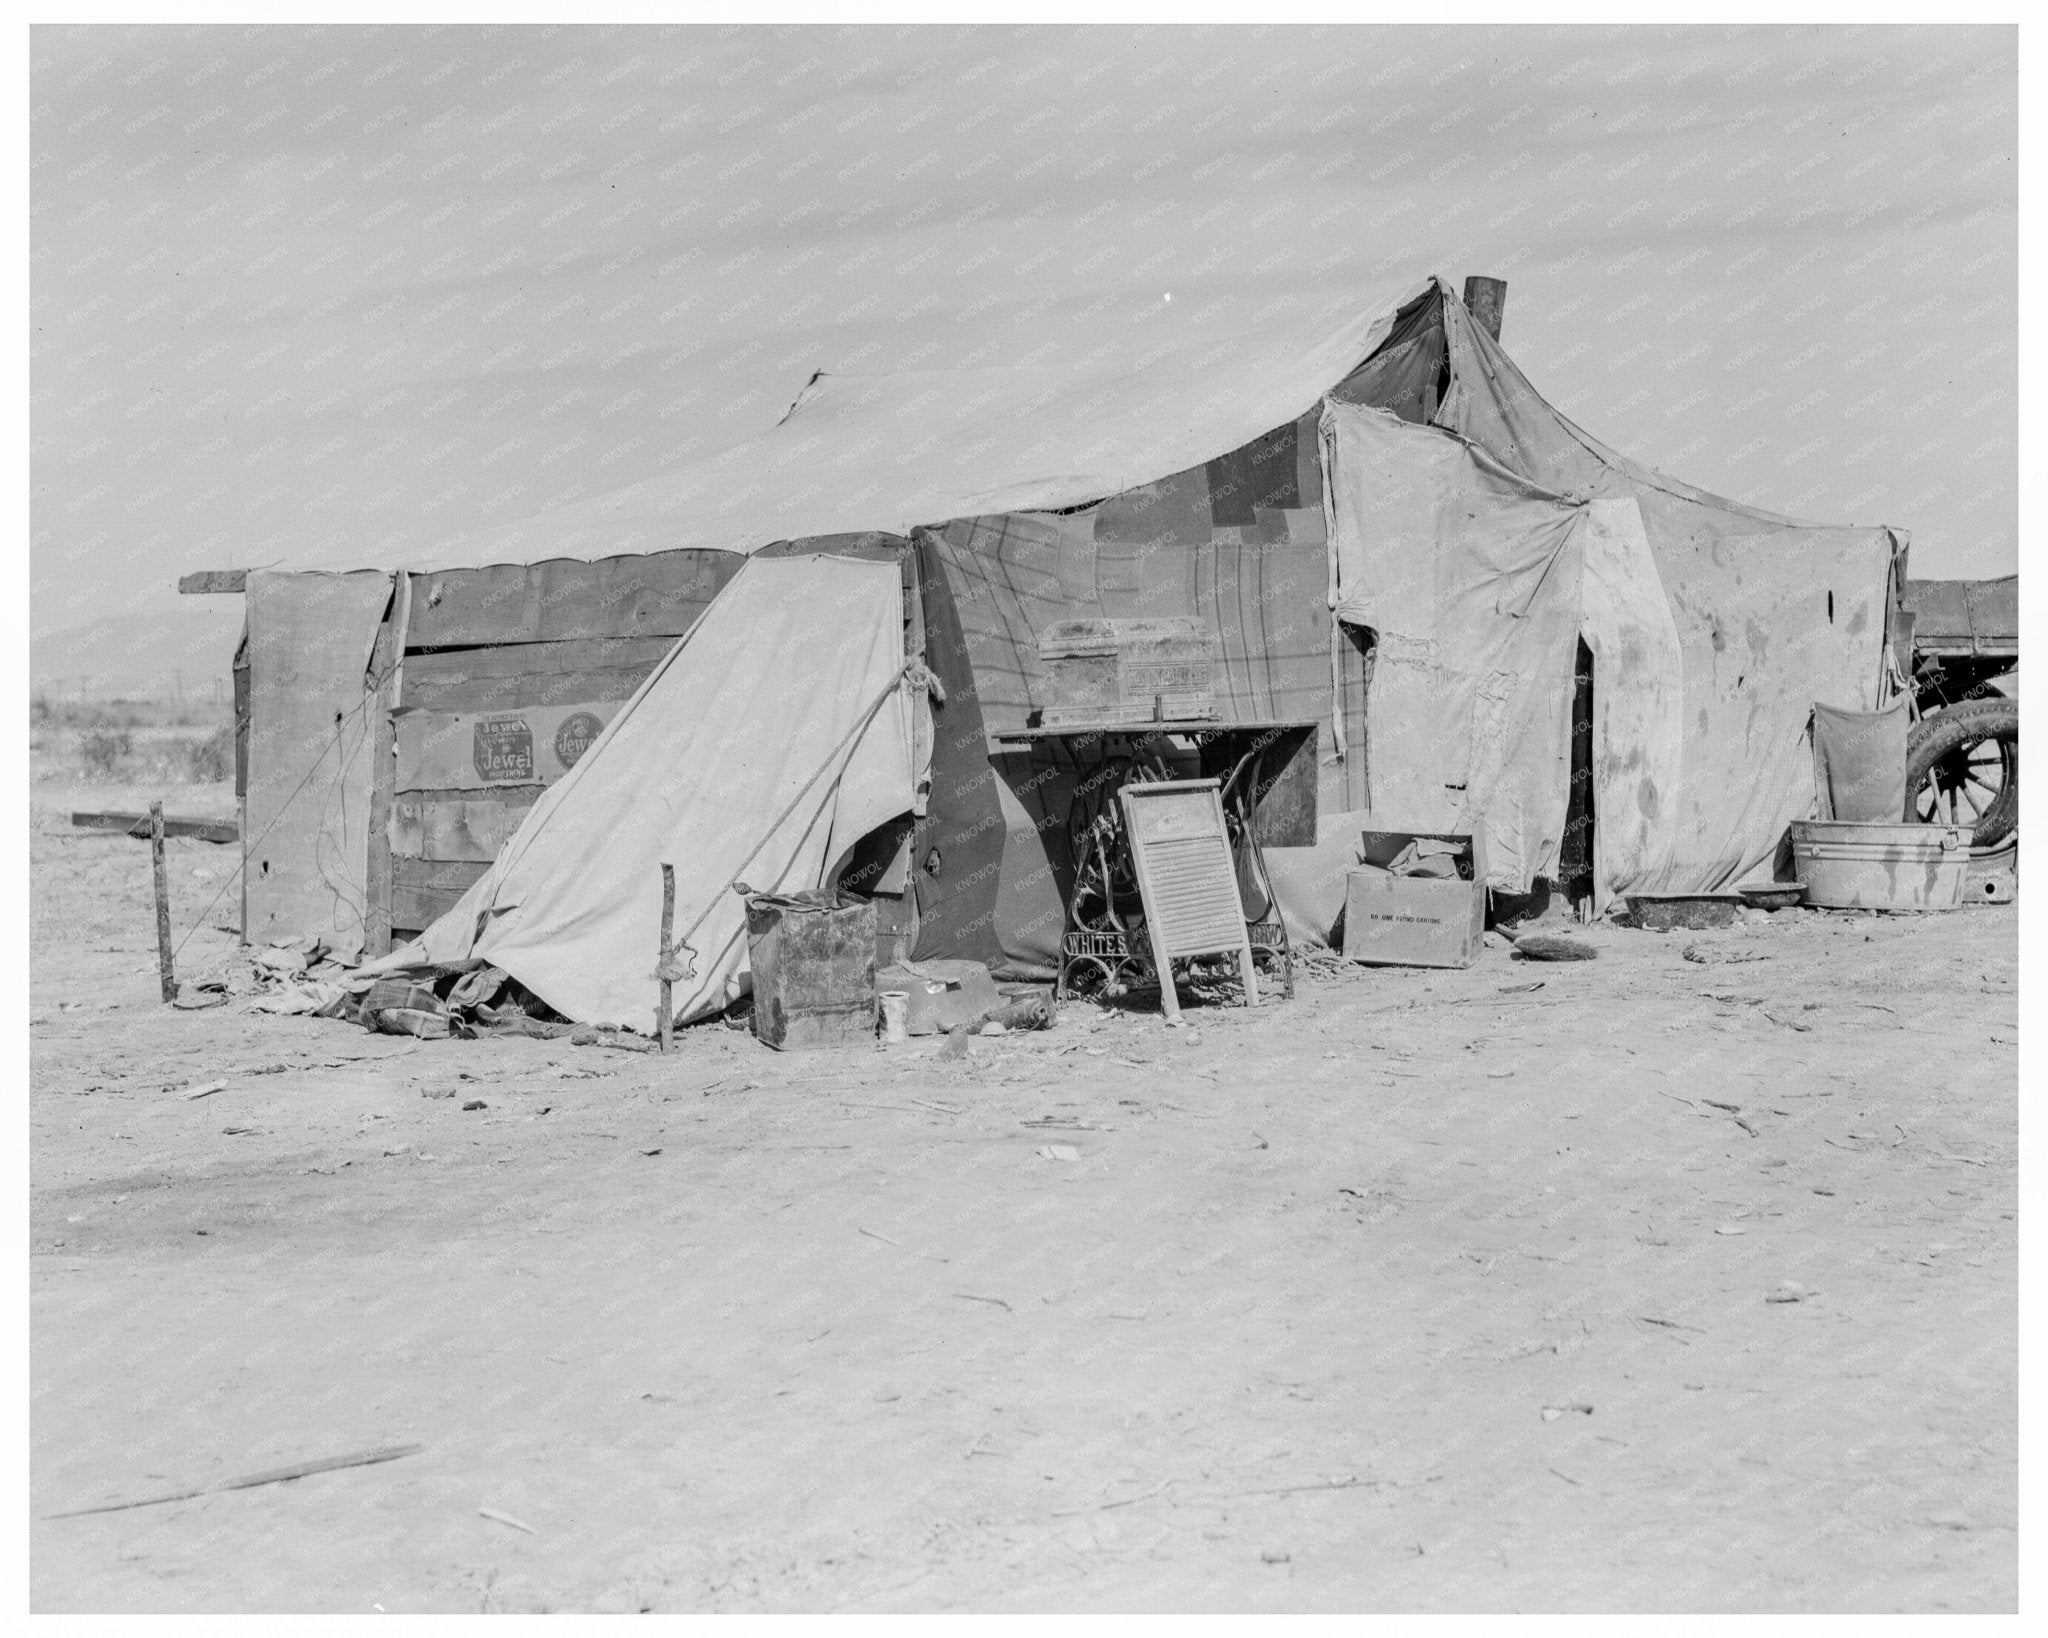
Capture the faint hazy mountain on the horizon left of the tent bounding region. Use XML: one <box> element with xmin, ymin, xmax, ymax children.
<box><xmin>29</xmin><ymin>598</ymin><xmax>242</xmax><ymax>700</ymax></box>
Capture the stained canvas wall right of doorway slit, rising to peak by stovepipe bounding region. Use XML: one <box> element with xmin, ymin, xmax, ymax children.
<box><xmin>1436</xmin><ymin>282</ymin><xmax>1894</xmax><ymax>893</ymax></box>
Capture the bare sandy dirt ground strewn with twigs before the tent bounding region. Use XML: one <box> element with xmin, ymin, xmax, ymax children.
<box><xmin>31</xmin><ymin>786</ymin><xmax>2017</xmax><ymax>1611</ymax></box>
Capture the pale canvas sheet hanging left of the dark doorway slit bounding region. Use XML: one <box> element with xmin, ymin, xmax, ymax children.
<box><xmin>1323</xmin><ymin>403</ymin><xmax>1581</xmax><ymax>893</ymax></box>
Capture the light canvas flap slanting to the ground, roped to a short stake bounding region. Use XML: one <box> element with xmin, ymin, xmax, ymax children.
<box><xmin>391</xmin><ymin>555</ymin><xmax>926</xmax><ymax>1030</ymax></box>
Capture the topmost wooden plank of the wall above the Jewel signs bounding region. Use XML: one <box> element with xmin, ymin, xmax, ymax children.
<box><xmin>408</xmin><ymin>549</ymin><xmax>745</xmax><ymax>649</ymax></box>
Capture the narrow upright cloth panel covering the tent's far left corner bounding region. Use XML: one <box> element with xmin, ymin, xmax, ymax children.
<box><xmin>242</xmin><ymin>571</ymin><xmax>391</xmax><ymax>956</ymax></box>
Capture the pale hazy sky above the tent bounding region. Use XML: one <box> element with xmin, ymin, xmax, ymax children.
<box><xmin>29</xmin><ymin>27</ymin><xmax>2017</xmax><ymax>688</ymax></box>
